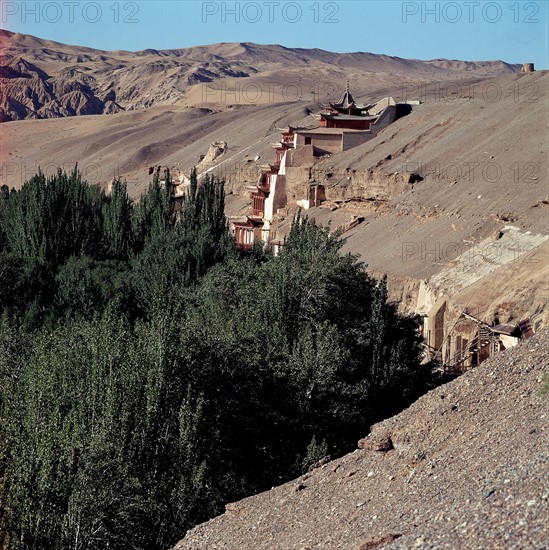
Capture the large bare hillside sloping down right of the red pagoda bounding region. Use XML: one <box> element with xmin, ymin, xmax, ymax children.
<box><xmin>283</xmin><ymin>71</ymin><xmax>549</xmax><ymax>327</ymax></box>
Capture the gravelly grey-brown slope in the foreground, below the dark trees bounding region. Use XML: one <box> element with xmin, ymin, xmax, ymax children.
<box><xmin>175</xmin><ymin>331</ymin><xmax>549</xmax><ymax>550</ymax></box>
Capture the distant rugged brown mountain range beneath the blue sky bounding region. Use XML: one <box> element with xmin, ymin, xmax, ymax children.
<box><xmin>0</xmin><ymin>30</ymin><xmax>518</xmax><ymax>122</ymax></box>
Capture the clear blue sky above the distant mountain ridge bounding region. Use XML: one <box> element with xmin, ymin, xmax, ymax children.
<box><xmin>0</xmin><ymin>0</ymin><xmax>549</xmax><ymax>69</ymax></box>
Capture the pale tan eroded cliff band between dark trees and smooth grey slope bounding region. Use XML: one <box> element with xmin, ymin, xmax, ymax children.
<box><xmin>223</xmin><ymin>167</ymin><xmax>549</xmax><ymax>368</ymax></box>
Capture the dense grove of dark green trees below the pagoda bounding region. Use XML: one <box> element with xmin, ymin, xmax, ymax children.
<box><xmin>0</xmin><ymin>169</ymin><xmax>433</xmax><ymax>550</ymax></box>
